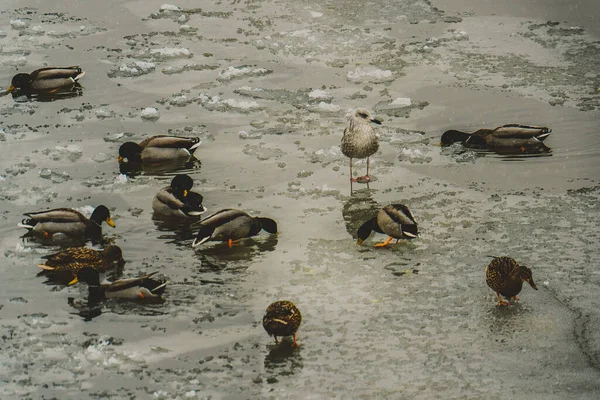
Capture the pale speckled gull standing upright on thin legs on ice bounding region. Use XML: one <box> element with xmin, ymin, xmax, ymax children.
<box><xmin>341</xmin><ymin>108</ymin><xmax>381</xmax><ymax>182</ymax></box>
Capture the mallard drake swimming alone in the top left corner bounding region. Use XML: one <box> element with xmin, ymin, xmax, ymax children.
<box><xmin>6</xmin><ymin>66</ymin><xmax>85</xmax><ymax>92</ymax></box>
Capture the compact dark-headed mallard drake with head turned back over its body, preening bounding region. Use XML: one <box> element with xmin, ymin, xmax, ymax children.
<box><xmin>152</xmin><ymin>174</ymin><xmax>206</xmax><ymax>218</ymax></box>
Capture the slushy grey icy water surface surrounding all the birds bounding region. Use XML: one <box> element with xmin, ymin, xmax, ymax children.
<box><xmin>0</xmin><ymin>0</ymin><xmax>600</xmax><ymax>399</ymax></box>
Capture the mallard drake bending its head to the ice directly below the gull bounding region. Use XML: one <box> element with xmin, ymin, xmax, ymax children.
<box><xmin>356</xmin><ymin>204</ymin><xmax>419</xmax><ymax>247</ymax></box>
